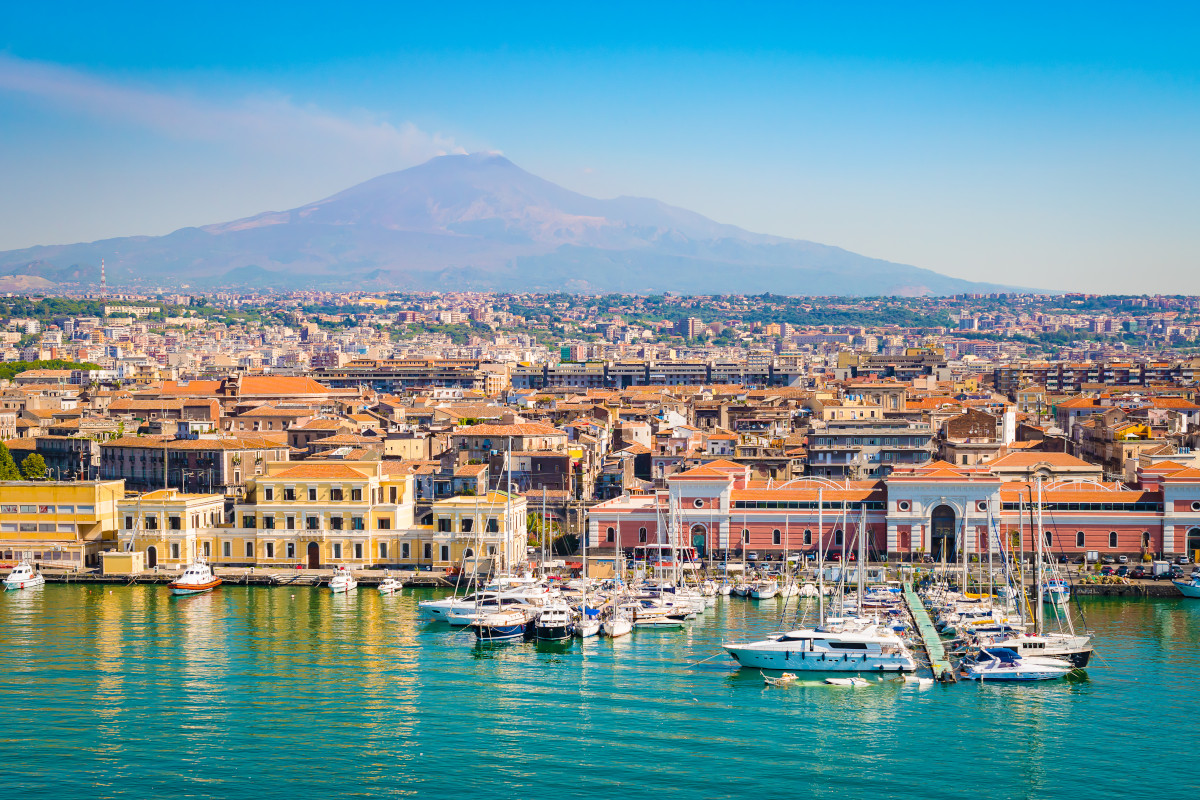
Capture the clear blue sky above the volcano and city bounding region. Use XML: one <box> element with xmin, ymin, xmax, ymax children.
<box><xmin>0</xmin><ymin>2</ymin><xmax>1200</xmax><ymax>294</ymax></box>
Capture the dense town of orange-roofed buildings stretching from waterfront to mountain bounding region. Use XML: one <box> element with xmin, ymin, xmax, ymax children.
<box><xmin>7</xmin><ymin>289</ymin><xmax>1200</xmax><ymax>571</ymax></box>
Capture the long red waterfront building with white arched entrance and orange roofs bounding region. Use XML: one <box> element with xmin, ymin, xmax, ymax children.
<box><xmin>587</xmin><ymin>453</ymin><xmax>1200</xmax><ymax>563</ymax></box>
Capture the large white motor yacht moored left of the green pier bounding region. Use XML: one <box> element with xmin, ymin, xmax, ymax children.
<box><xmin>724</xmin><ymin>620</ymin><xmax>917</xmax><ymax>672</ymax></box>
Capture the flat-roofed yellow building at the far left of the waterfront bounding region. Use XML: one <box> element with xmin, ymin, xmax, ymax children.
<box><xmin>0</xmin><ymin>481</ymin><xmax>125</xmax><ymax>569</ymax></box>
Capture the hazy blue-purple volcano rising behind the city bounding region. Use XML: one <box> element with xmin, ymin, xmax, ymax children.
<box><xmin>0</xmin><ymin>154</ymin><xmax>1022</xmax><ymax>295</ymax></box>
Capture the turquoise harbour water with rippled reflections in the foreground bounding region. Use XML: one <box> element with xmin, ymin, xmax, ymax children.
<box><xmin>0</xmin><ymin>585</ymin><xmax>1200</xmax><ymax>800</ymax></box>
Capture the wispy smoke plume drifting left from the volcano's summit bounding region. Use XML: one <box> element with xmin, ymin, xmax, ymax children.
<box><xmin>0</xmin><ymin>54</ymin><xmax>466</xmax><ymax>168</ymax></box>
